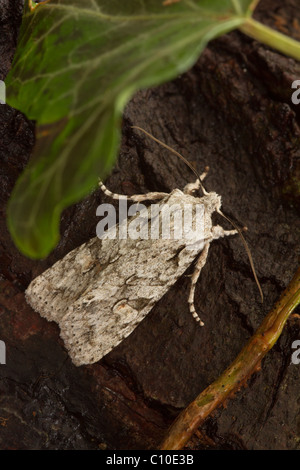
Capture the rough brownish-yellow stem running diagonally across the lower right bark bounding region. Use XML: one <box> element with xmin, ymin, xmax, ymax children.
<box><xmin>161</xmin><ymin>268</ymin><xmax>300</xmax><ymax>450</ymax></box>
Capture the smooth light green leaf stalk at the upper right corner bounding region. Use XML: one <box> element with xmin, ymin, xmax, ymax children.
<box><xmin>239</xmin><ymin>18</ymin><xmax>300</xmax><ymax>60</ymax></box>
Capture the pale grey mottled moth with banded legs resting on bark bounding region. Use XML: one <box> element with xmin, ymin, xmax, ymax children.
<box><xmin>26</xmin><ymin>127</ymin><xmax>258</xmax><ymax>366</ymax></box>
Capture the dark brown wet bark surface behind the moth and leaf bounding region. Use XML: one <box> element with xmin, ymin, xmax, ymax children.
<box><xmin>0</xmin><ymin>0</ymin><xmax>300</xmax><ymax>449</ymax></box>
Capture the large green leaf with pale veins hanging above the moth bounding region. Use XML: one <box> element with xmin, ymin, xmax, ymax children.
<box><xmin>6</xmin><ymin>0</ymin><xmax>257</xmax><ymax>258</ymax></box>
